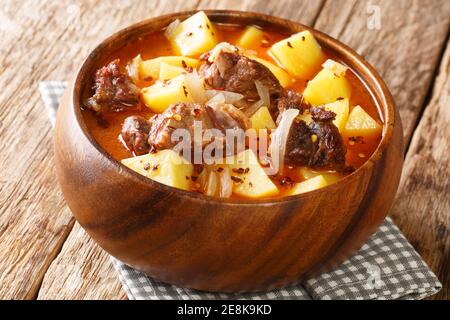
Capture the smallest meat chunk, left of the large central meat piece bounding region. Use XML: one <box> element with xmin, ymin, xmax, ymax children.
<box><xmin>121</xmin><ymin>116</ymin><xmax>151</xmax><ymax>156</ymax></box>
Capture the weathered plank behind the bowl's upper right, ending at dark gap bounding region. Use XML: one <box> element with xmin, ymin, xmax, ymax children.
<box><xmin>315</xmin><ymin>0</ymin><xmax>450</xmax><ymax>141</ymax></box>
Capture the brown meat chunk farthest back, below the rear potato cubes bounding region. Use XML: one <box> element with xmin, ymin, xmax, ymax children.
<box><xmin>200</xmin><ymin>51</ymin><xmax>283</xmax><ymax>112</ymax></box>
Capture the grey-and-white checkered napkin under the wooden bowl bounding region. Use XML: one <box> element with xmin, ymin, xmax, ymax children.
<box><xmin>39</xmin><ymin>81</ymin><xmax>442</xmax><ymax>300</ymax></box>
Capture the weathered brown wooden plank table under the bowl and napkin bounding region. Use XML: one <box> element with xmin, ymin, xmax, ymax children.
<box><xmin>0</xmin><ymin>0</ymin><xmax>450</xmax><ymax>299</ymax></box>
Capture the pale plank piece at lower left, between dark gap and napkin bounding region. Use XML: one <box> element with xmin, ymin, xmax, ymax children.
<box><xmin>38</xmin><ymin>223</ymin><xmax>126</xmax><ymax>299</ymax></box>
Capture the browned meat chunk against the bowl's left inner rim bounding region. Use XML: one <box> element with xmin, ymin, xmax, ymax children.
<box><xmin>85</xmin><ymin>59</ymin><xmax>139</xmax><ymax>113</ymax></box>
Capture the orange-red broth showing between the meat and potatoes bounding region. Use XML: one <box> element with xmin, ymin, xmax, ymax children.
<box><xmin>82</xmin><ymin>24</ymin><xmax>382</xmax><ymax>198</ymax></box>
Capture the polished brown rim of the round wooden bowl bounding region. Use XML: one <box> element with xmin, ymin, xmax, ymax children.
<box><xmin>69</xmin><ymin>9</ymin><xmax>400</xmax><ymax>206</ymax></box>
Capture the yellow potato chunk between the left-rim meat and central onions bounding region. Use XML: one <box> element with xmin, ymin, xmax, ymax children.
<box><xmin>141</xmin><ymin>75</ymin><xmax>193</xmax><ymax>113</ymax></box>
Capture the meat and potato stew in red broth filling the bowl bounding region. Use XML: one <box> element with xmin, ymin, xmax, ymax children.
<box><xmin>82</xmin><ymin>12</ymin><xmax>382</xmax><ymax>198</ymax></box>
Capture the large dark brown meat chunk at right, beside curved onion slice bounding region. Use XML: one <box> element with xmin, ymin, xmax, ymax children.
<box><xmin>285</xmin><ymin>107</ymin><xmax>346</xmax><ymax>171</ymax></box>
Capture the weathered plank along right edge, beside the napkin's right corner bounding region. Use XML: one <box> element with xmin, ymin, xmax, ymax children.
<box><xmin>392</xmin><ymin>41</ymin><xmax>450</xmax><ymax>300</ymax></box>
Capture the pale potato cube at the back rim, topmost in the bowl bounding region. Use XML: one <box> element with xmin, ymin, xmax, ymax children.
<box><xmin>168</xmin><ymin>11</ymin><xmax>217</xmax><ymax>56</ymax></box>
